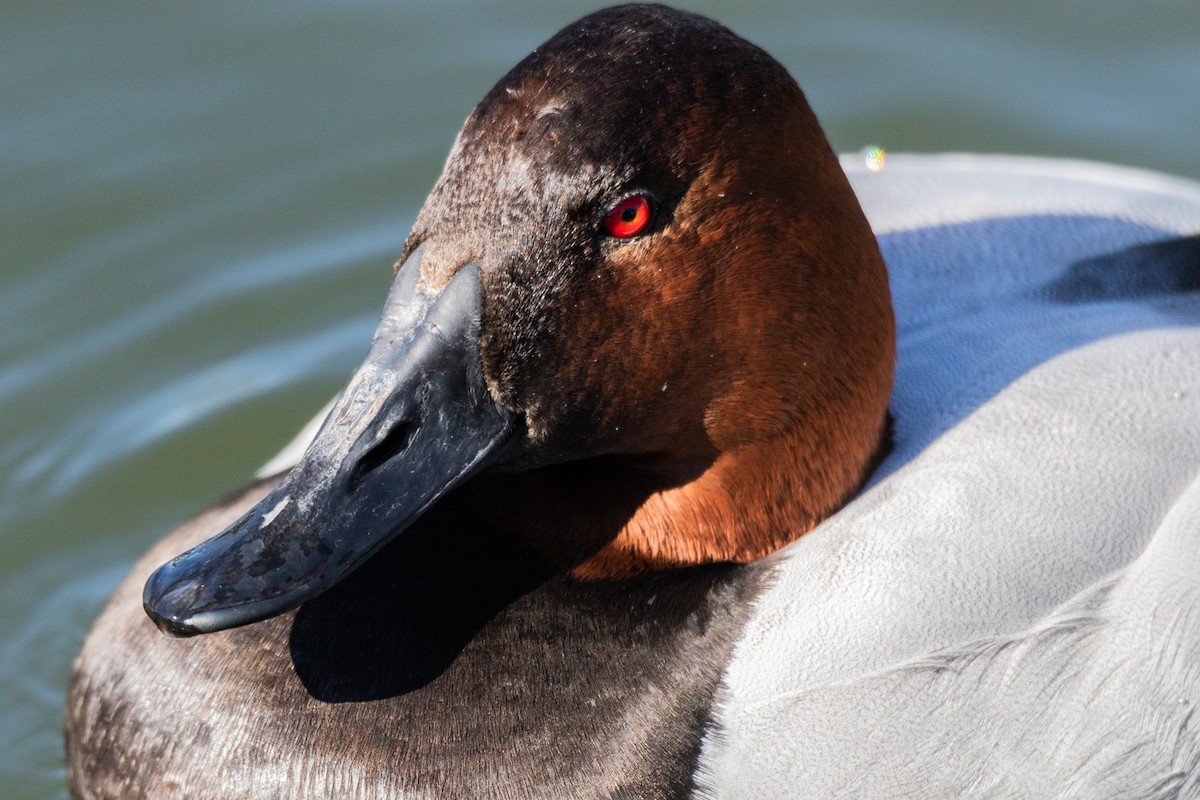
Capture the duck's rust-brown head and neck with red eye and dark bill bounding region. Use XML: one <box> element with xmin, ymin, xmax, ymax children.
<box><xmin>144</xmin><ymin>5</ymin><xmax>895</xmax><ymax>634</ymax></box>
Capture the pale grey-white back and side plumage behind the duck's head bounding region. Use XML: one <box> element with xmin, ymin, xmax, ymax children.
<box><xmin>701</xmin><ymin>156</ymin><xmax>1200</xmax><ymax>798</ymax></box>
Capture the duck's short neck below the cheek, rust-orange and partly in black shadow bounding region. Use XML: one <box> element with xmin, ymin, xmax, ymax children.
<box><xmin>472</xmin><ymin>410</ymin><xmax>886</xmax><ymax>579</ymax></box>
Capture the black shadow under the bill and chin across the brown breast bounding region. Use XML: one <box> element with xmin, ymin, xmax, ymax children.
<box><xmin>289</xmin><ymin>458</ymin><xmax>679</xmax><ymax>703</ymax></box>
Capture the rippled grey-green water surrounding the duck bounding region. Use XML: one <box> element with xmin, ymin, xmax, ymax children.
<box><xmin>0</xmin><ymin>0</ymin><xmax>1200</xmax><ymax>799</ymax></box>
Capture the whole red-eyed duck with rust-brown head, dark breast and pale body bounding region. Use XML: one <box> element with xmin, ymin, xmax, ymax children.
<box><xmin>67</xmin><ymin>5</ymin><xmax>1200</xmax><ymax>799</ymax></box>
